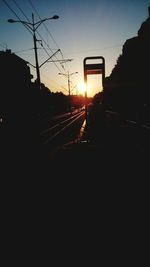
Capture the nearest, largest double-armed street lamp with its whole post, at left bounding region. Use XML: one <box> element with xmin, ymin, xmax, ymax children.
<box><xmin>7</xmin><ymin>13</ymin><xmax>59</xmax><ymax>89</ymax></box>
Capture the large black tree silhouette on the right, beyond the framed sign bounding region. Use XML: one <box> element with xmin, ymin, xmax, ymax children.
<box><xmin>104</xmin><ymin>6</ymin><xmax>150</xmax><ymax>121</ymax></box>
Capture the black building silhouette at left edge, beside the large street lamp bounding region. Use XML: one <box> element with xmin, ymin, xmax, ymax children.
<box><xmin>0</xmin><ymin>50</ymin><xmax>32</xmax><ymax>121</ymax></box>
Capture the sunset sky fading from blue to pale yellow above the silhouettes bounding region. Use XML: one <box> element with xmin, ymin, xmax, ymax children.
<box><xmin>0</xmin><ymin>0</ymin><xmax>150</xmax><ymax>96</ymax></box>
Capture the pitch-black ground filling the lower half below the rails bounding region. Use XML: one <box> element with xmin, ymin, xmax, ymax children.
<box><xmin>1</xmin><ymin>124</ymin><xmax>149</xmax><ymax>263</ymax></box>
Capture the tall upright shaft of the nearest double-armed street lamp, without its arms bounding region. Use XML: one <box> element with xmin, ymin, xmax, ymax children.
<box><xmin>32</xmin><ymin>13</ymin><xmax>41</xmax><ymax>89</ymax></box>
